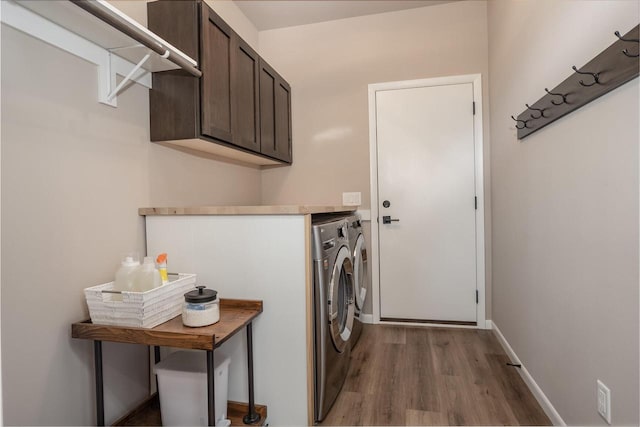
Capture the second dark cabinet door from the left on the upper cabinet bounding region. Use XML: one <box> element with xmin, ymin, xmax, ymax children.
<box><xmin>231</xmin><ymin>36</ymin><xmax>260</xmax><ymax>153</ymax></box>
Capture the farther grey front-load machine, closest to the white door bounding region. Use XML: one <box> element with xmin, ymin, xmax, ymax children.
<box><xmin>346</xmin><ymin>215</ymin><xmax>367</xmax><ymax>348</ymax></box>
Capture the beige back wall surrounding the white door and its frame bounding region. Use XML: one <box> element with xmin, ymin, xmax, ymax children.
<box><xmin>260</xmin><ymin>1</ymin><xmax>491</xmax><ymax>318</ymax></box>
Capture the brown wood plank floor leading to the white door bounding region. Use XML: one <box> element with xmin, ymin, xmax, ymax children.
<box><xmin>322</xmin><ymin>325</ymin><xmax>551</xmax><ymax>426</ymax></box>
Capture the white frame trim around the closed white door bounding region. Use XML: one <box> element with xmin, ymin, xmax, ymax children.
<box><xmin>369</xmin><ymin>74</ymin><xmax>488</xmax><ymax>329</ymax></box>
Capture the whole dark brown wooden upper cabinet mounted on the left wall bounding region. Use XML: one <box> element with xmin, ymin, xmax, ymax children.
<box><xmin>147</xmin><ymin>0</ymin><xmax>291</xmax><ymax>164</ymax></box>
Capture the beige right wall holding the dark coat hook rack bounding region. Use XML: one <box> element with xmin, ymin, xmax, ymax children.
<box><xmin>488</xmin><ymin>0</ymin><xmax>640</xmax><ymax>425</ymax></box>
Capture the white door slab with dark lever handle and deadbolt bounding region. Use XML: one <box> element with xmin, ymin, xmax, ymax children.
<box><xmin>375</xmin><ymin>83</ymin><xmax>477</xmax><ymax>322</ymax></box>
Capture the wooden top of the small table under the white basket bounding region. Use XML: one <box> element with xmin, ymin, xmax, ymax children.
<box><xmin>71</xmin><ymin>299</ymin><xmax>262</xmax><ymax>350</ymax></box>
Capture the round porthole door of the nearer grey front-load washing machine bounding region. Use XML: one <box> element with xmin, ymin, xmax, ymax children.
<box><xmin>328</xmin><ymin>246</ymin><xmax>354</xmax><ymax>353</ymax></box>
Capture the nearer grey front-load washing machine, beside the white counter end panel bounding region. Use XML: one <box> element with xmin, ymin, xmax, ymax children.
<box><xmin>312</xmin><ymin>218</ymin><xmax>355</xmax><ymax>422</ymax></box>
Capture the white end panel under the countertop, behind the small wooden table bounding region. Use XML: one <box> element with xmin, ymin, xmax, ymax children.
<box><xmin>146</xmin><ymin>215</ymin><xmax>307</xmax><ymax>425</ymax></box>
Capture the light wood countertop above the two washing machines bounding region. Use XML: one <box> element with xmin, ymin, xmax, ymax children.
<box><xmin>138</xmin><ymin>205</ymin><xmax>357</xmax><ymax>216</ymax></box>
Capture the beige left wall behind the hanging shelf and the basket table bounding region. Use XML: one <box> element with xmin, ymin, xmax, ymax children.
<box><xmin>0</xmin><ymin>2</ymin><xmax>261</xmax><ymax>425</ymax></box>
